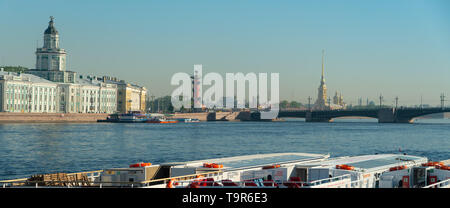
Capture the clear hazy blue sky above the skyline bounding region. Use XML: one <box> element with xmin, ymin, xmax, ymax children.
<box><xmin>0</xmin><ymin>0</ymin><xmax>450</xmax><ymax>105</ymax></box>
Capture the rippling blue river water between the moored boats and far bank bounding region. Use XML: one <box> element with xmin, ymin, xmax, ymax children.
<box><xmin>0</xmin><ymin>119</ymin><xmax>450</xmax><ymax>180</ymax></box>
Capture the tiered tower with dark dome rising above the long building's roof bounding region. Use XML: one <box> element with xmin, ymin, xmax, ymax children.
<box><xmin>36</xmin><ymin>16</ymin><xmax>66</xmax><ymax>71</ymax></box>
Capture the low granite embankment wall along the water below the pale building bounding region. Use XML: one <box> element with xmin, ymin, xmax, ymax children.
<box><xmin>0</xmin><ymin>112</ymin><xmax>109</xmax><ymax>123</ymax></box>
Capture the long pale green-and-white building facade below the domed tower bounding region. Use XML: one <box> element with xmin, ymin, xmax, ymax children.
<box><xmin>0</xmin><ymin>72</ymin><xmax>117</xmax><ymax>113</ymax></box>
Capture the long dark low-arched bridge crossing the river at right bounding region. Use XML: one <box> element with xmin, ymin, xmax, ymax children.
<box><xmin>272</xmin><ymin>108</ymin><xmax>450</xmax><ymax>123</ymax></box>
